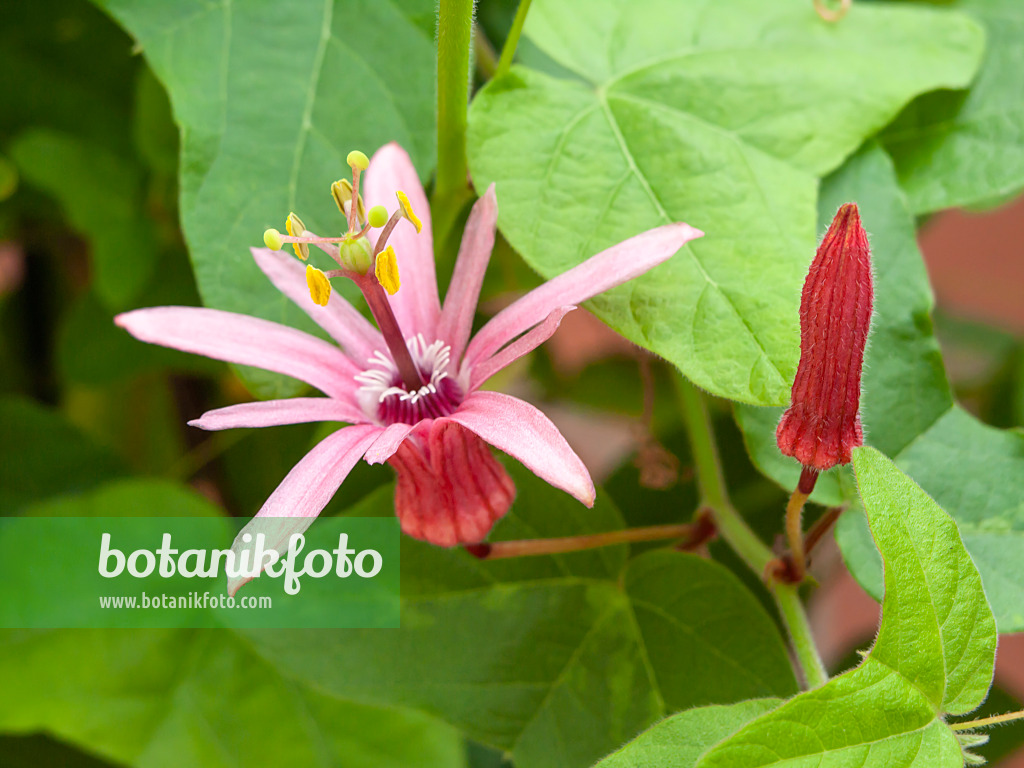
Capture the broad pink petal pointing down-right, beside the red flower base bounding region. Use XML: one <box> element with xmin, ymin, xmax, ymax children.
<box><xmin>446</xmin><ymin>392</ymin><xmax>596</xmax><ymax>507</ymax></box>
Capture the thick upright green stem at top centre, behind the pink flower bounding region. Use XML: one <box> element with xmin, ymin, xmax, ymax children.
<box><xmin>432</xmin><ymin>0</ymin><xmax>473</xmax><ymax>250</ymax></box>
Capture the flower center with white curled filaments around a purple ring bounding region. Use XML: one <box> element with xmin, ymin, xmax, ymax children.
<box><xmin>355</xmin><ymin>334</ymin><xmax>464</xmax><ymax>426</ymax></box>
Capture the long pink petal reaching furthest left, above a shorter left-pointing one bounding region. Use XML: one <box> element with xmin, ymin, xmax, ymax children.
<box><xmin>114</xmin><ymin>306</ymin><xmax>359</xmax><ymax>398</ymax></box>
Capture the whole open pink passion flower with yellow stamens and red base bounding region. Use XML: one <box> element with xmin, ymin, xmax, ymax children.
<box><xmin>116</xmin><ymin>143</ymin><xmax>701</xmax><ymax>594</ymax></box>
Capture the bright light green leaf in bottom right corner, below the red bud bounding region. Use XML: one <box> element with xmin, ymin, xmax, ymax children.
<box><xmin>697</xmin><ymin>447</ymin><xmax>996</xmax><ymax>768</ymax></box>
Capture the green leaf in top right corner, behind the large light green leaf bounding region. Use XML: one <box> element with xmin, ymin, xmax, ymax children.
<box><xmin>882</xmin><ymin>0</ymin><xmax>1024</xmax><ymax>214</ymax></box>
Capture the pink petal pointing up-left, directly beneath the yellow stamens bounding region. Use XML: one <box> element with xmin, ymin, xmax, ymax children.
<box><xmin>251</xmin><ymin>248</ymin><xmax>384</xmax><ymax>366</ymax></box>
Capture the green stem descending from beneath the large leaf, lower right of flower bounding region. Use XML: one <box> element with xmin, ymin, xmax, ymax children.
<box><xmin>676</xmin><ymin>375</ymin><xmax>828</xmax><ymax>688</ymax></box>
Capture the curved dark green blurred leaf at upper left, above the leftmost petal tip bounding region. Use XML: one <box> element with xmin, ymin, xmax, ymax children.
<box><xmin>10</xmin><ymin>129</ymin><xmax>158</xmax><ymax>309</ymax></box>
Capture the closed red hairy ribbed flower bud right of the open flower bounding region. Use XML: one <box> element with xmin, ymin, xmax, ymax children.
<box><xmin>775</xmin><ymin>203</ymin><xmax>872</xmax><ymax>472</ymax></box>
